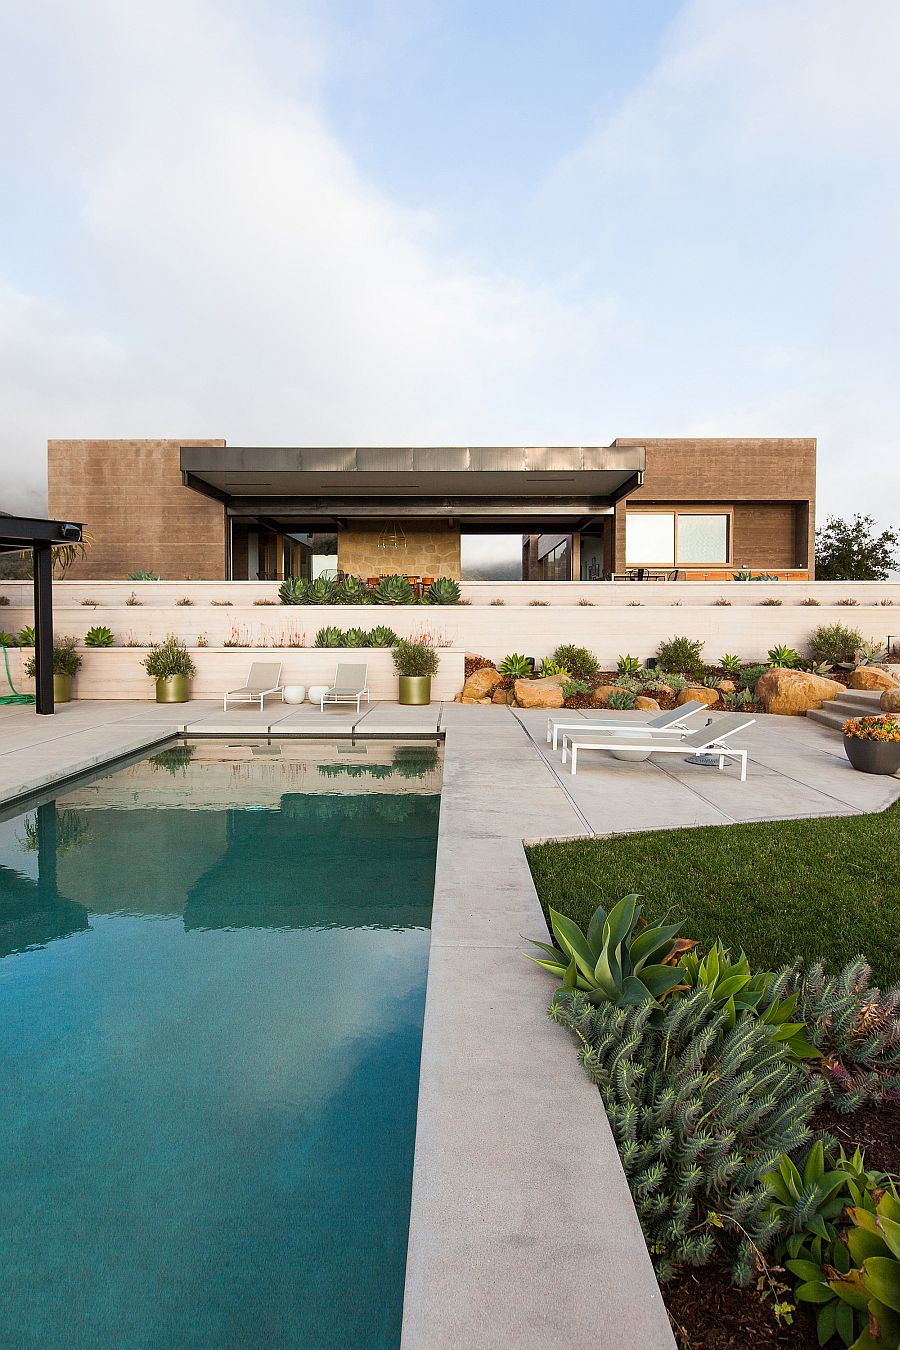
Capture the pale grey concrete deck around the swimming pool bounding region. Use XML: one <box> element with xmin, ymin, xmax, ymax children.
<box><xmin>0</xmin><ymin>702</ymin><xmax>900</xmax><ymax>1350</ymax></box>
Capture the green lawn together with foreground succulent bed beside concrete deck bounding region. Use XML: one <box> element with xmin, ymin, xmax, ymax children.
<box><xmin>528</xmin><ymin>805</ymin><xmax>900</xmax><ymax>1350</ymax></box>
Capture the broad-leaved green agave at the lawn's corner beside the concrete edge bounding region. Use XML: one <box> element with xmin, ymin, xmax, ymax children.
<box><xmin>529</xmin><ymin>895</ymin><xmax>695</xmax><ymax>1004</ymax></box>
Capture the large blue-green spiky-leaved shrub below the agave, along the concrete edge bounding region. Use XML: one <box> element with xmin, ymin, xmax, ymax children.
<box><xmin>549</xmin><ymin>988</ymin><xmax>823</xmax><ymax>1284</ymax></box>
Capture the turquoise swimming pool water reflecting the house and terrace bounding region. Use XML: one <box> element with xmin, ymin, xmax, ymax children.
<box><xmin>0</xmin><ymin>743</ymin><xmax>440</xmax><ymax>1350</ymax></box>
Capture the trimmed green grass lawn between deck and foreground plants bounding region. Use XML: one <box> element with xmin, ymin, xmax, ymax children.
<box><xmin>528</xmin><ymin>803</ymin><xmax>900</xmax><ymax>988</ymax></box>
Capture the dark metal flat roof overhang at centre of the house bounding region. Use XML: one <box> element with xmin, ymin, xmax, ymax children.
<box><xmin>181</xmin><ymin>446</ymin><xmax>645</xmax><ymax>525</ymax></box>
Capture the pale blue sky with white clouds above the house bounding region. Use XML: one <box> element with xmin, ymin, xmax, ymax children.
<box><xmin>0</xmin><ymin>0</ymin><xmax>900</xmax><ymax>524</ymax></box>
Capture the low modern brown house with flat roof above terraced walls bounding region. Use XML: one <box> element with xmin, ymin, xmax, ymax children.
<box><xmin>49</xmin><ymin>439</ymin><xmax>816</xmax><ymax>581</ymax></box>
